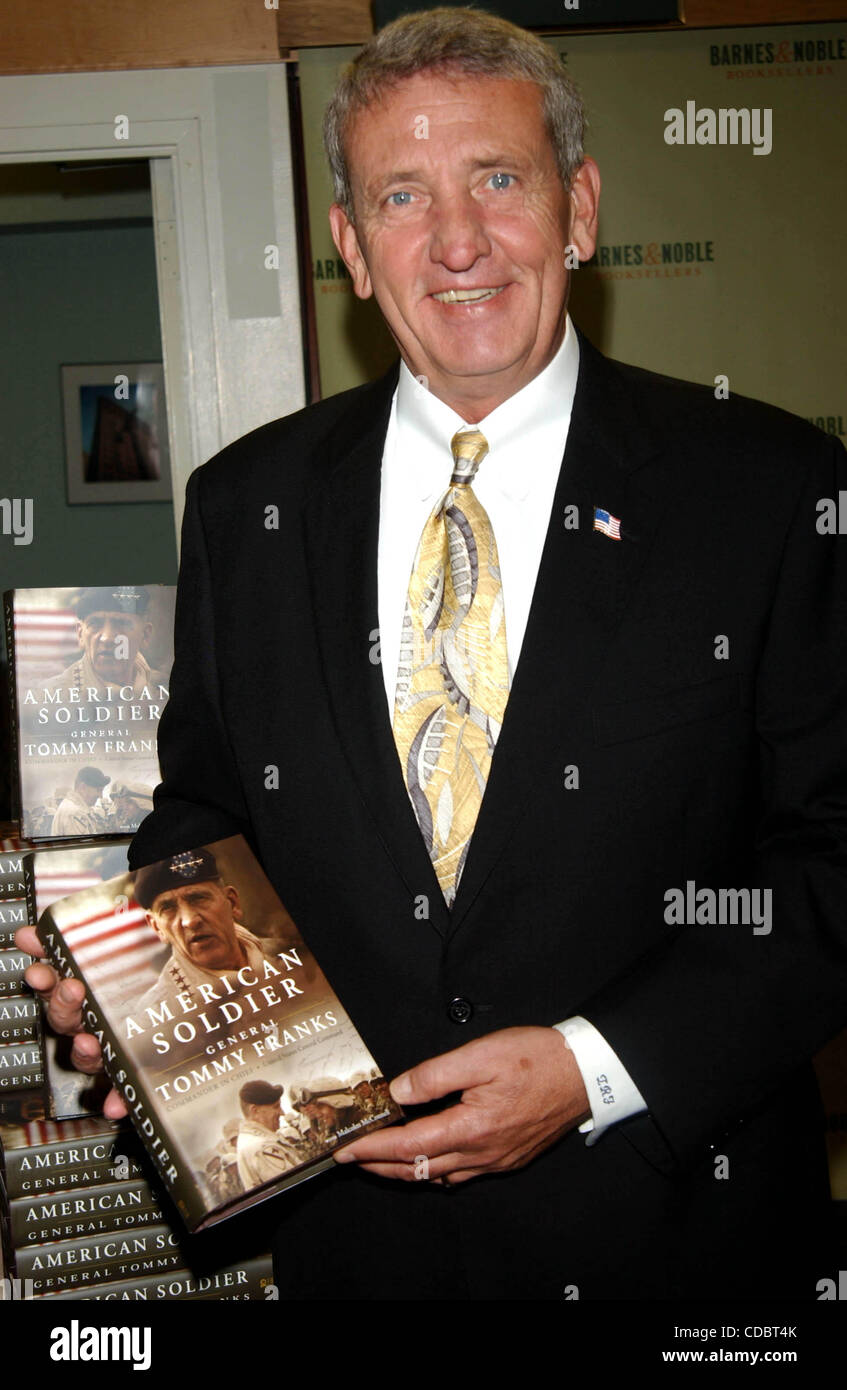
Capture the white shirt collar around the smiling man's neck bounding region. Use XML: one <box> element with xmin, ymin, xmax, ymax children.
<box><xmin>396</xmin><ymin>316</ymin><xmax>580</xmax><ymax>500</ymax></box>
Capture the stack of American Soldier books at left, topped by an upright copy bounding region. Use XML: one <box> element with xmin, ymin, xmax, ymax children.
<box><xmin>0</xmin><ymin>584</ymin><xmax>273</xmax><ymax>1300</ymax></box>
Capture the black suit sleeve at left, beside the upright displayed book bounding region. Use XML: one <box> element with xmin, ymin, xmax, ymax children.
<box><xmin>129</xmin><ymin>473</ymin><xmax>250</xmax><ymax>869</ymax></box>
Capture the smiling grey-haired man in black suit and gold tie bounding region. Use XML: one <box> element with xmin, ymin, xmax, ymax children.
<box><xmin>23</xmin><ymin>11</ymin><xmax>847</xmax><ymax>1298</ymax></box>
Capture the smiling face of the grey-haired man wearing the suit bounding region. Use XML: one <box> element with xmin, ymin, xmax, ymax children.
<box><xmin>330</xmin><ymin>72</ymin><xmax>599</xmax><ymax>423</ymax></box>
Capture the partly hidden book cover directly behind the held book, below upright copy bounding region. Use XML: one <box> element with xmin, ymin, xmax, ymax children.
<box><xmin>24</xmin><ymin>840</ymin><xmax>129</xmax><ymax>1120</ymax></box>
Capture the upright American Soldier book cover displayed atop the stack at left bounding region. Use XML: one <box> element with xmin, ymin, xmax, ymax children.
<box><xmin>6</xmin><ymin>584</ymin><xmax>175</xmax><ymax>841</ymax></box>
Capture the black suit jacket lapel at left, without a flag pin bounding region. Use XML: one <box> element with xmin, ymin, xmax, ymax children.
<box><xmin>305</xmin><ymin>367</ymin><xmax>448</xmax><ymax>934</ymax></box>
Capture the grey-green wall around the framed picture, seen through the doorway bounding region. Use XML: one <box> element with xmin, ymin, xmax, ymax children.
<box><xmin>0</xmin><ymin>214</ymin><xmax>177</xmax><ymax>589</ymax></box>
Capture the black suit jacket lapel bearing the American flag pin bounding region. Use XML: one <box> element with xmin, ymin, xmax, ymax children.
<box><xmin>449</xmin><ymin>334</ymin><xmax>670</xmax><ymax>933</ymax></box>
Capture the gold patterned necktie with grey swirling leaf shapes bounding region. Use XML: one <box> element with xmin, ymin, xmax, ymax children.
<box><xmin>394</xmin><ymin>430</ymin><xmax>509</xmax><ymax>906</ymax></box>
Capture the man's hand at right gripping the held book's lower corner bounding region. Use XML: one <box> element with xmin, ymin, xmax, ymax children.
<box><xmin>335</xmin><ymin>1027</ymin><xmax>591</xmax><ymax>1186</ymax></box>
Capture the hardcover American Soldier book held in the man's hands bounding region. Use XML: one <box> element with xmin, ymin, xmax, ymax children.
<box><xmin>38</xmin><ymin>835</ymin><xmax>402</xmax><ymax>1230</ymax></box>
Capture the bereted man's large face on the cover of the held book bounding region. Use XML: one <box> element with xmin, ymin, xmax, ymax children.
<box><xmin>147</xmin><ymin>880</ymin><xmax>243</xmax><ymax>970</ymax></box>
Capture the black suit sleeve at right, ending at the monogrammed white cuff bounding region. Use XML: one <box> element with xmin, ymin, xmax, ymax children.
<box><xmin>584</xmin><ymin>439</ymin><xmax>847</xmax><ymax>1163</ymax></box>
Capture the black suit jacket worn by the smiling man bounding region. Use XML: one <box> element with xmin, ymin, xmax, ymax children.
<box><xmin>132</xmin><ymin>330</ymin><xmax>847</xmax><ymax>1298</ymax></box>
